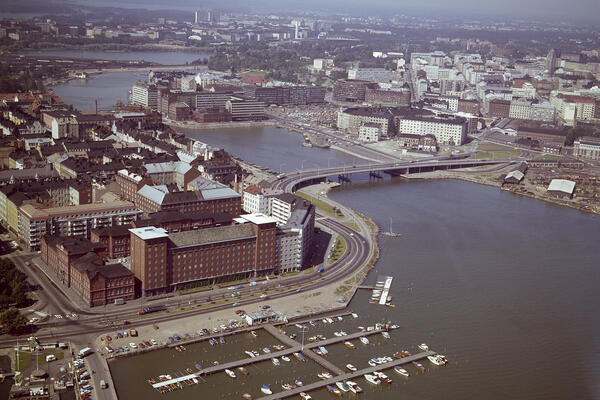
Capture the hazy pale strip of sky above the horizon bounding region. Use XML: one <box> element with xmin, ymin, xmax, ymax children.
<box><xmin>80</xmin><ymin>0</ymin><xmax>600</xmax><ymax>24</ymax></box>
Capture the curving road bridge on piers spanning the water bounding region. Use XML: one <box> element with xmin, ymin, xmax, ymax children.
<box><xmin>271</xmin><ymin>158</ymin><xmax>519</xmax><ymax>192</ymax></box>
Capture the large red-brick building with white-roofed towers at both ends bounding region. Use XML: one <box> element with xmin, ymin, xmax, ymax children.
<box><xmin>130</xmin><ymin>214</ymin><xmax>276</xmax><ymax>295</ymax></box>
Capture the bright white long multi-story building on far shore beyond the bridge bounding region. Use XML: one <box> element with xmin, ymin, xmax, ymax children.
<box><xmin>398</xmin><ymin>111</ymin><xmax>467</xmax><ymax>145</ymax></box>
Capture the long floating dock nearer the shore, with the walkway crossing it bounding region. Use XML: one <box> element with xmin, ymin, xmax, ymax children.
<box><xmin>152</xmin><ymin>325</ymin><xmax>392</xmax><ymax>393</ymax></box>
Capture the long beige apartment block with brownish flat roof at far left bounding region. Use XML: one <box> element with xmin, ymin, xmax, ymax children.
<box><xmin>18</xmin><ymin>201</ymin><xmax>142</xmax><ymax>250</ymax></box>
